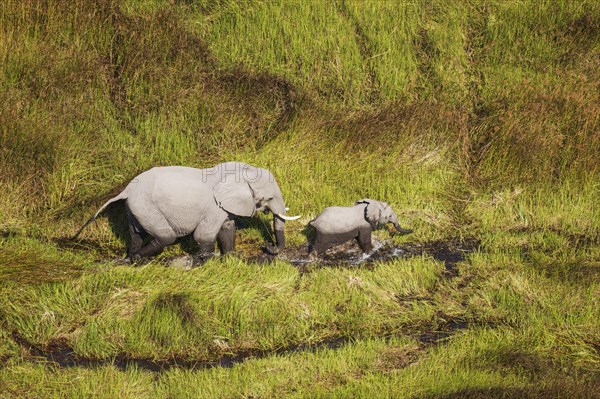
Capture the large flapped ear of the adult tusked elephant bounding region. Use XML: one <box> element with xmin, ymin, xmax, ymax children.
<box><xmin>213</xmin><ymin>175</ymin><xmax>255</xmax><ymax>216</ymax></box>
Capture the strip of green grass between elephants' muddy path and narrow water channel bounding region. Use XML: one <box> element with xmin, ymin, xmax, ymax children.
<box><xmin>2</xmin><ymin>259</ymin><xmax>441</xmax><ymax>360</ymax></box>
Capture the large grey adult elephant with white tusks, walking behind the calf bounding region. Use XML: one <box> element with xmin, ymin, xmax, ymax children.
<box><xmin>73</xmin><ymin>162</ymin><xmax>299</xmax><ymax>261</ymax></box>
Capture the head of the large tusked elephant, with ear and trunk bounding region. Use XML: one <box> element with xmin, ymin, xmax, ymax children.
<box><xmin>213</xmin><ymin>162</ymin><xmax>300</xmax><ymax>252</ymax></box>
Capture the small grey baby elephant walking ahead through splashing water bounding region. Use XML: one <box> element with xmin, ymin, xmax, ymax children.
<box><xmin>309</xmin><ymin>198</ymin><xmax>412</xmax><ymax>255</ymax></box>
